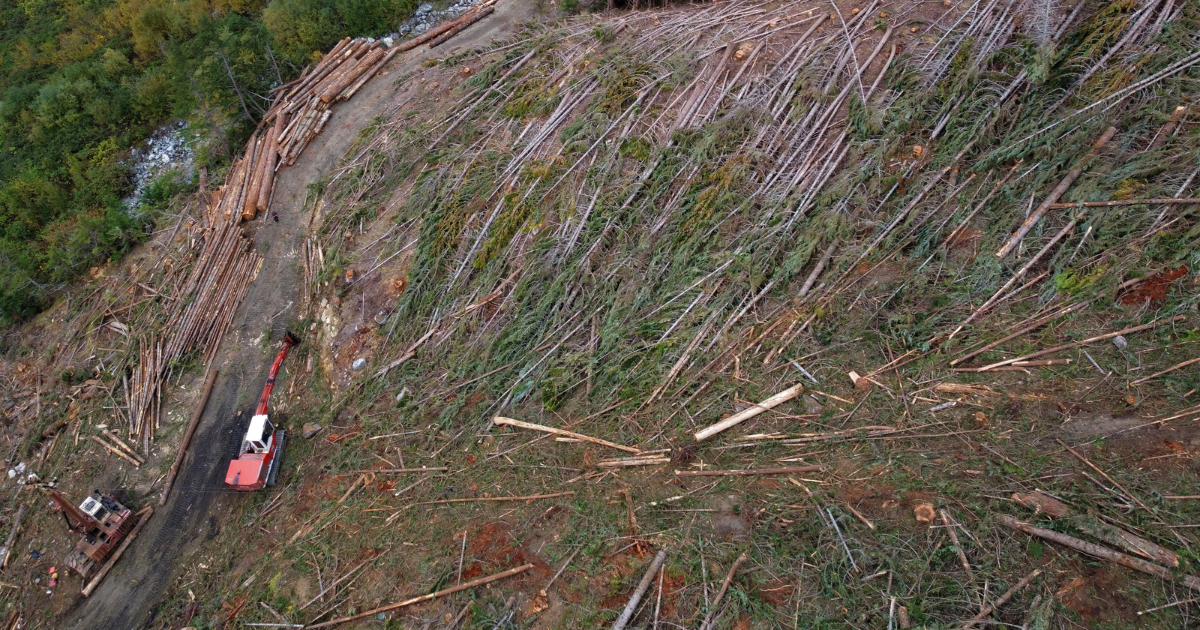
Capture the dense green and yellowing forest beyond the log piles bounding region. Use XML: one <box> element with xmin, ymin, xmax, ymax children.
<box><xmin>0</xmin><ymin>0</ymin><xmax>418</xmax><ymax>325</ymax></box>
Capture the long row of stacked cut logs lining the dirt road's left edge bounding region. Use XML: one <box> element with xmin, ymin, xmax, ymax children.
<box><xmin>125</xmin><ymin>7</ymin><xmax>494</xmax><ymax>454</ymax></box>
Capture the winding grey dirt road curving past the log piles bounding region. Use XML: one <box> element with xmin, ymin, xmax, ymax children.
<box><xmin>62</xmin><ymin>0</ymin><xmax>528</xmax><ymax>630</ymax></box>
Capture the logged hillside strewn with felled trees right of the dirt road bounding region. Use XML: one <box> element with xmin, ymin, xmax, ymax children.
<box><xmin>2</xmin><ymin>0</ymin><xmax>1200</xmax><ymax>629</ymax></box>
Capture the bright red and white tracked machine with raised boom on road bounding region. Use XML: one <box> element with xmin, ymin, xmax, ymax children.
<box><xmin>226</xmin><ymin>332</ymin><xmax>300</xmax><ymax>491</ymax></box>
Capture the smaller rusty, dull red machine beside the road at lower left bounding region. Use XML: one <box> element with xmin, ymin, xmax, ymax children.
<box><xmin>50</xmin><ymin>490</ymin><xmax>137</xmax><ymax>577</ymax></box>
